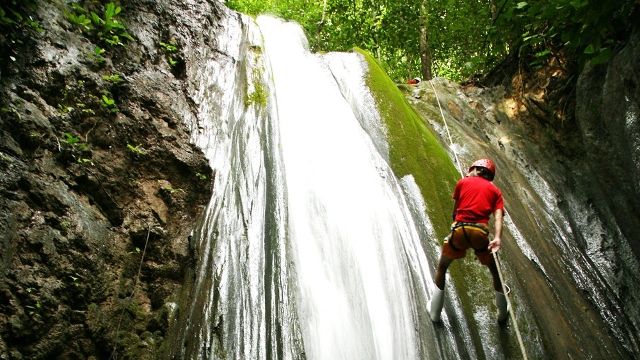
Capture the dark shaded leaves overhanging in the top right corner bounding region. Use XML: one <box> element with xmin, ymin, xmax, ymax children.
<box><xmin>490</xmin><ymin>0</ymin><xmax>636</xmax><ymax>67</ymax></box>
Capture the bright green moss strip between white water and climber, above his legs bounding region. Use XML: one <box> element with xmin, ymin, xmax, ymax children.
<box><xmin>355</xmin><ymin>48</ymin><xmax>460</xmax><ymax>242</ymax></box>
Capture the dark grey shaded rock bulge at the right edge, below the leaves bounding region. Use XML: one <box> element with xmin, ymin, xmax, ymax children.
<box><xmin>576</xmin><ymin>26</ymin><xmax>640</xmax><ymax>258</ymax></box>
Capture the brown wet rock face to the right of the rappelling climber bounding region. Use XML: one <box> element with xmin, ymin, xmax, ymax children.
<box><xmin>401</xmin><ymin>26</ymin><xmax>640</xmax><ymax>359</ymax></box>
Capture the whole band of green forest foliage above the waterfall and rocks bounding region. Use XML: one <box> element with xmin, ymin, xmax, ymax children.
<box><xmin>226</xmin><ymin>0</ymin><xmax>635</xmax><ymax>81</ymax></box>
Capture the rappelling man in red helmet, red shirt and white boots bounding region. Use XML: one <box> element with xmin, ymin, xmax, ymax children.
<box><xmin>427</xmin><ymin>159</ymin><xmax>509</xmax><ymax>322</ymax></box>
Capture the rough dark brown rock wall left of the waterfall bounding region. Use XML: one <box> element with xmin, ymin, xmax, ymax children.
<box><xmin>0</xmin><ymin>1</ymin><xmax>219</xmax><ymax>359</ymax></box>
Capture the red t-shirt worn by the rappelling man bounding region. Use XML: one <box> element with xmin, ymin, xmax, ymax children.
<box><xmin>453</xmin><ymin>176</ymin><xmax>504</xmax><ymax>223</ymax></box>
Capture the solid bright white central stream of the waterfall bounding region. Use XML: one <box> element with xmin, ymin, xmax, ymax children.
<box><xmin>258</xmin><ymin>17</ymin><xmax>432</xmax><ymax>359</ymax></box>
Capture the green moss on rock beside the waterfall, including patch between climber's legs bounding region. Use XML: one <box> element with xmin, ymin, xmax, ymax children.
<box><xmin>356</xmin><ymin>49</ymin><xmax>493</xmax><ymax>354</ymax></box>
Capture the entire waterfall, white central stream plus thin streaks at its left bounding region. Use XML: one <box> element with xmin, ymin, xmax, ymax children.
<box><xmin>165</xmin><ymin>11</ymin><xmax>438</xmax><ymax>359</ymax></box>
